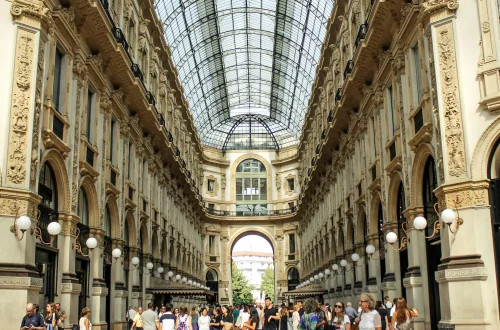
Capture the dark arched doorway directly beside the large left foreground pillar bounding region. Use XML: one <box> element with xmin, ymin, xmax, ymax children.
<box><xmin>35</xmin><ymin>162</ymin><xmax>58</xmax><ymax>310</ymax></box>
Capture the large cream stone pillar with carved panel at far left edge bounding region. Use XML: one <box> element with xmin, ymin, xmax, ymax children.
<box><xmin>0</xmin><ymin>0</ymin><xmax>50</xmax><ymax>329</ymax></box>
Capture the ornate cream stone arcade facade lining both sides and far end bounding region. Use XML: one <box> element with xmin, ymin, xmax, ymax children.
<box><xmin>0</xmin><ymin>0</ymin><xmax>500</xmax><ymax>330</ymax></box>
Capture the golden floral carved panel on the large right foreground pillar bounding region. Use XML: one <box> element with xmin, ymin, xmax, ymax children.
<box><xmin>437</xmin><ymin>25</ymin><xmax>465</xmax><ymax>177</ymax></box>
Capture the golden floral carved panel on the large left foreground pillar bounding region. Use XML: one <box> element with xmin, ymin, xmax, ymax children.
<box><xmin>7</xmin><ymin>30</ymin><xmax>34</xmax><ymax>184</ymax></box>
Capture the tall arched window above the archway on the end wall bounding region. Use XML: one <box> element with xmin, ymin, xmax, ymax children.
<box><xmin>236</xmin><ymin>158</ymin><xmax>268</xmax><ymax>215</ymax></box>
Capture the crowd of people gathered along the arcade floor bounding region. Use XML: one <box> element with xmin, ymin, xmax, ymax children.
<box><xmin>21</xmin><ymin>293</ymin><xmax>418</xmax><ymax>330</ymax></box>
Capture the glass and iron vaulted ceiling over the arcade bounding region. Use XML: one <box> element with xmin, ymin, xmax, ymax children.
<box><xmin>155</xmin><ymin>0</ymin><xmax>333</xmax><ymax>150</ymax></box>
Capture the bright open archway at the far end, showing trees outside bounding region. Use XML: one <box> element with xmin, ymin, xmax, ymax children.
<box><xmin>232</xmin><ymin>232</ymin><xmax>278</xmax><ymax>305</ymax></box>
